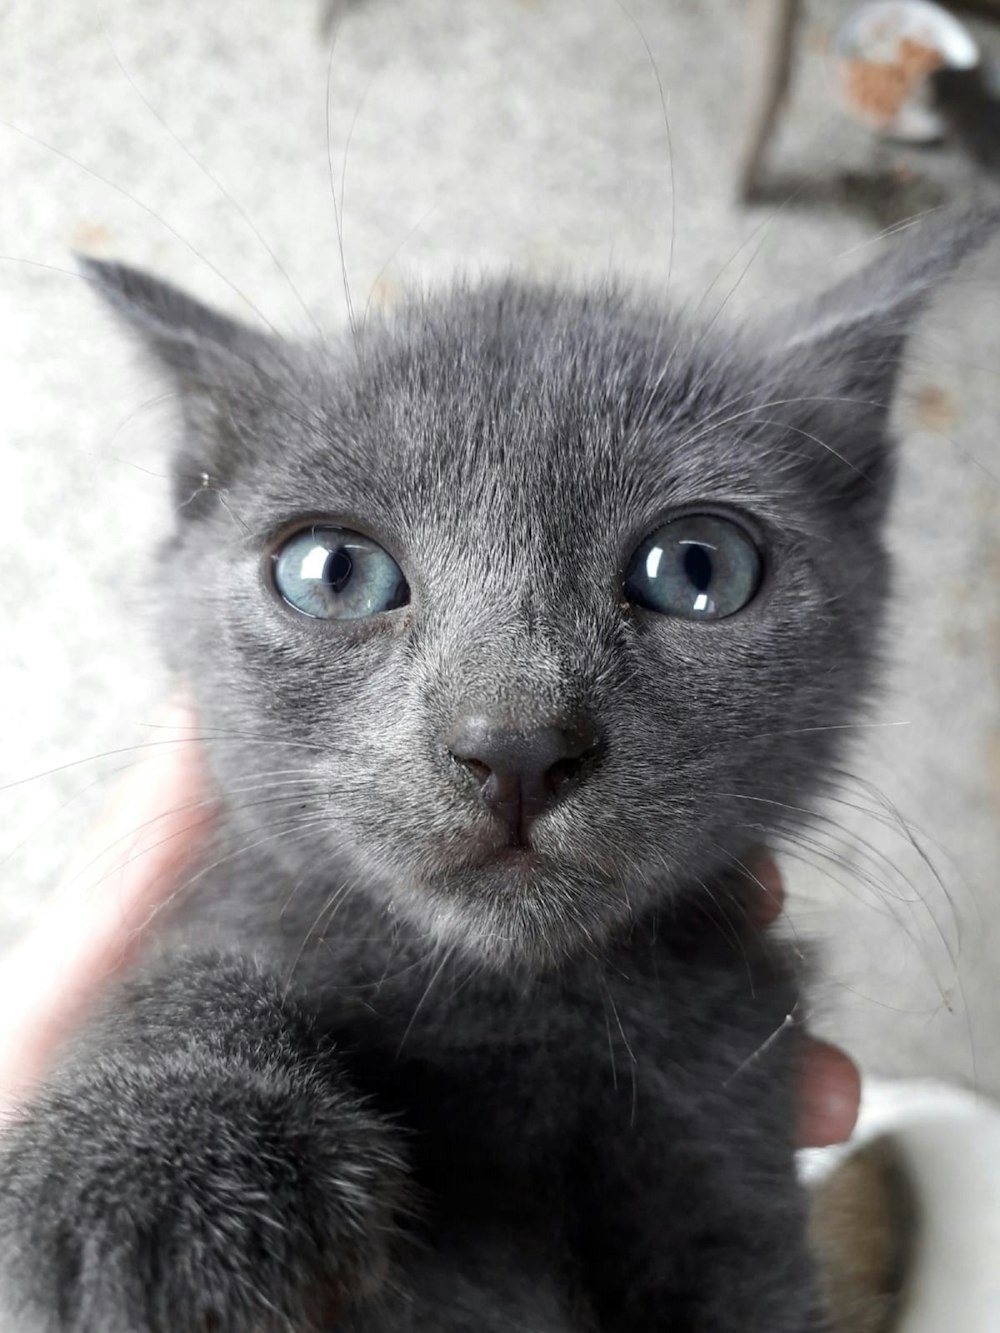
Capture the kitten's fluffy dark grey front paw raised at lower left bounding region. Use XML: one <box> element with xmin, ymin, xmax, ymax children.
<box><xmin>0</xmin><ymin>957</ymin><xmax>405</xmax><ymax>1333</ymax></box>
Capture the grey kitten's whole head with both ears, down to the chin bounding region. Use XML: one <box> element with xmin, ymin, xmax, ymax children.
<box><xmin>87</xmin><ymin>216</ymin><xmax>995</xmax><ymax>962</ymax></box>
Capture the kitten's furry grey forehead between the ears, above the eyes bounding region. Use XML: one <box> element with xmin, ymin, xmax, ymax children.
<box><xmin>260</xmin><ymin>285</ymin><xmax>761</xmax><ymax>553</ymax></box>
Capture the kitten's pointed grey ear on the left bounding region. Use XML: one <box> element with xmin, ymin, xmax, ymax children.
<box><xmin>76</xmin><ymin>256</ymin><xmax>288</xmax><ymax>513</ymax></box>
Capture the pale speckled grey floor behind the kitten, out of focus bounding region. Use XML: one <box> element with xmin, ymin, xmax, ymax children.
<box><xmin>0</xmin><ymin>0</ymin><xmax>1000</xmax><ymax>1093</ymax></box>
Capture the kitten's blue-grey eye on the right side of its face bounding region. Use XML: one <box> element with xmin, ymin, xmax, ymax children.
<box><xmin>625</xmin><ymin>513</ymin><xmax>763</xmax><ymax>620</ymax></box>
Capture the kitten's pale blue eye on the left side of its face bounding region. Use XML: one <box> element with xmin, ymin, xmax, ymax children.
<box><xmin>271</xmin><ymin>525</ymin><xmax>409</xmax><ymax>620</ymax></box>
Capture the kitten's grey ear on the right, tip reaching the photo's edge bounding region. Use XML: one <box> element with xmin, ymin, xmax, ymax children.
<box><xmin>764</xmin><ymin>207</ymin><xmax>1000</xmax><ymax>500</ymax></box>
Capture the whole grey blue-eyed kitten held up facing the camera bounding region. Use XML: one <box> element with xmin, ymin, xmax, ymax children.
<box><xmin>0</xmin><ymin>215</ymin><xmax>996</xmax><ymax>1333</ymax></box>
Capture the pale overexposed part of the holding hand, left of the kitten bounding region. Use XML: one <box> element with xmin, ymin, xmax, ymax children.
<box><xmin>0</xmin><ymin>705</ymin><xmax>212</xmax><ymax>1102</ymax></box>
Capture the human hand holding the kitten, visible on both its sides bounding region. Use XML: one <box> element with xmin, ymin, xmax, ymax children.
<box><xmin>0</xmin><ymin>725</ymin><xmax>860</xmax><ymax>1148</ymax></box>
